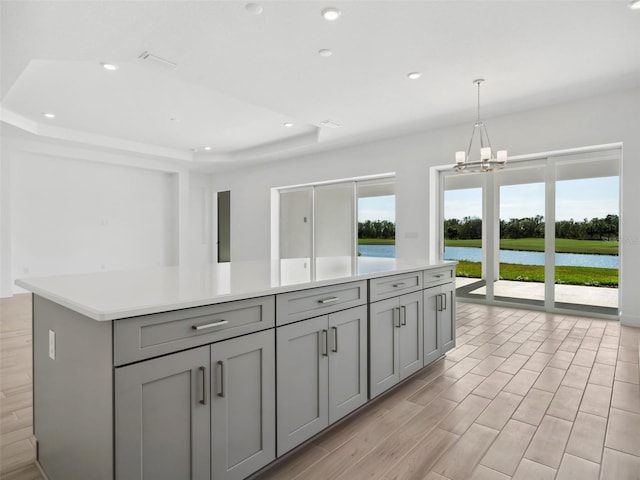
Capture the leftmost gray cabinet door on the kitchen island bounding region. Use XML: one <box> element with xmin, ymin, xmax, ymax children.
<box><xmin>115</xmin><ymin>346</ymin><xmax>211</xmax><ymax>480</ymax></box>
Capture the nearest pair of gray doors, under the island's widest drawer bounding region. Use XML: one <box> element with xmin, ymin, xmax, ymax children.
<box><xmin>115</xmin><ymin>329</ymin><xmax>276</xmax><ymax>480</ymax></box>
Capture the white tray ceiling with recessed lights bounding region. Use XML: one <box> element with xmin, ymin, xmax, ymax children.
<box><xmin>0</xmin><ymin>0</ymin><xmax>640</xmax><ymax>168</ymax></box>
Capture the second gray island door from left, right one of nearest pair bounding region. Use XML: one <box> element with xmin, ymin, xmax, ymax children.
<box><xmin>211</xmin><ymin>330</ymin><xmax>276</xmax><ymax>480</ymax></box>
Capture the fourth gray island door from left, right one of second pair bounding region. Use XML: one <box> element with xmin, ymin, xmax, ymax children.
<box><xmin>329</xmin><ymin>305</ymin><xmax>368</xmax><ymax>423</ymax></box>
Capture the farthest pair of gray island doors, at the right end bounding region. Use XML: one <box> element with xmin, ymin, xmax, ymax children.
<box><xmin>424</xmin><ymin>282</ymin><xmax>456</xmax><ymax>366</ymax></box>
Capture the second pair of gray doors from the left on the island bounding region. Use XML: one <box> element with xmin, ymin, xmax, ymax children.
<box><xmin>276</xmin><ymin>306</ymin><xmax>367</xmax><ymax>455</ymax></box>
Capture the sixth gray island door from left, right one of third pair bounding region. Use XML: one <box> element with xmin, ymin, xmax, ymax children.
<box><xmin>399</xmin><ymin>291</ymin><xmax>424</xmax><ymax>380</ymax></box>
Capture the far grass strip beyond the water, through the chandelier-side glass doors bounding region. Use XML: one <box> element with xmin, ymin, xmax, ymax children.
<box><xmin>444</xmin><ymin>238</ymin><xmax>618</xmax><ymax>255</ymax></box>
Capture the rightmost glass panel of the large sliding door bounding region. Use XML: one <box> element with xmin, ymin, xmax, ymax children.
<box><xmin>554</xmin><ymin>157</ymin><xmax>620</xmax><ymax>314</ymax></box>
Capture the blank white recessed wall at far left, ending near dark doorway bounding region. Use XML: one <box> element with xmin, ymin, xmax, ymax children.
<box><xmin>0</xmin><ymin>135</ymin><xmax>211</xmax><ymax>296</ymax></box>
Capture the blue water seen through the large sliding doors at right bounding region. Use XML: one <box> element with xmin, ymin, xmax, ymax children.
<box><xmin>444</xmin><ymin>247</ymin><xmax>619</xmax><ymax>268</ymax></box>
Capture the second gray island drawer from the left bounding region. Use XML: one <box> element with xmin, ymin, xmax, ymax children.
<box><xmin>276</xmin><ymin>280</ymin><xmax>367</xmax><ymax>325</ymax></box>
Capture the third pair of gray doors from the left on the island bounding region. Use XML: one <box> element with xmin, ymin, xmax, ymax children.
<box><xmin>369</xmin><ymin>291</ymin><xmax>424</xmax><ymax>398</ymax></box>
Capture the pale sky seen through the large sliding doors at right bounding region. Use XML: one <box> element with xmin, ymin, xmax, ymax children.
<box><xmin>444</xmin><ymin>177</ymin><xmax>619</xmax><ymax>221</ymax></box>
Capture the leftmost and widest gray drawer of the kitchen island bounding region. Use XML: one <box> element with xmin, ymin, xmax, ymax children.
<box><xmin>113</xmin><ymin>296</ymin><xmax>275</xmax><ymax>365</ymax></box>
